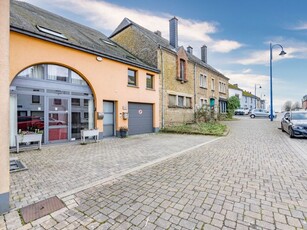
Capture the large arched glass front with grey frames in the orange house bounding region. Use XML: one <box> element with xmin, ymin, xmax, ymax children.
<box><xmin>10</xmin><ymin>64</ymin><xmax>94</xmax><ymax>146</ymax></box>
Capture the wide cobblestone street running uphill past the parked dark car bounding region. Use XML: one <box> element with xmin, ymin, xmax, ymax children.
<box><xmin>0</xmin><ymin>119</ymin><xmax>307</xmax><ymax>230</ymax></box>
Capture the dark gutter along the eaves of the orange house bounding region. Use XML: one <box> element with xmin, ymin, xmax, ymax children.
<box><xmin>10</xmin><ymin>26</ymin><xmax>160</xmax><ymax>73</ymax></box>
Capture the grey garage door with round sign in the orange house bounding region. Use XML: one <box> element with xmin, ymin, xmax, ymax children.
<box><xmin>128</xmin><ymin>103</ymin><xmax>153</xmax><ymax>135</ymax></box>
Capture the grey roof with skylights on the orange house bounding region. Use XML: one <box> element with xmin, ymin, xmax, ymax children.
<box><xmin>10</xmin><ymin>1</ymin><xmax>159</xmax><ymax>72</ymax></box>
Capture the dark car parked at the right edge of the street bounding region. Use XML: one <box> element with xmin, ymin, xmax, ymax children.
<box><xmin>281</xmin><ymin>111</ymin><xmax>307</xmax><ymax>138</ymax></box>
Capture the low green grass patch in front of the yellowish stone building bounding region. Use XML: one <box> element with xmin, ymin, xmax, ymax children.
<box><xmin>161</xmin><ymin>122</ymin><xmax>227</xmax><ymax>136</ymax></box>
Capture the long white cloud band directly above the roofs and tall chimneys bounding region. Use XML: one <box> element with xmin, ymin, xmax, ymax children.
<box><xmin>27</xmin><ymin>0</ymin><xmax>242</xmax><ymax>53</ymax></box>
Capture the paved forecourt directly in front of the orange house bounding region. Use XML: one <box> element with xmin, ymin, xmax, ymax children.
<box><xmin>10</xmin><ymin>134</ymin><xmax>216</xmax><ymax>209</ymax></box>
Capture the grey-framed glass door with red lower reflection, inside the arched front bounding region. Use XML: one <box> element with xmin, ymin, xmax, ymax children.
<box><xmin>47</xmin><ymin>97</ymin><xmax>69</xmax><ymax>142</ymax></box>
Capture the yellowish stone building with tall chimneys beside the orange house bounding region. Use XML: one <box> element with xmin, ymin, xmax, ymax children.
<box><xmin>110</xmin><ymin>17</ymin><xmax>229</xmax><ymax>127</ymax></box>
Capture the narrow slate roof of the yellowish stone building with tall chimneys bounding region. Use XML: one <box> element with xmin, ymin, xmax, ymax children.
<box><xmin>109</xmin><ymin>18</ymin><xmax>229</xmax><ymax>80</ymax></box>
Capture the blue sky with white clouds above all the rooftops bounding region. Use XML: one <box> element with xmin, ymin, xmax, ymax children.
<box><xmin>24</xmin><ymin>0</ymin><xmax>307</xmax><ymax>111</ymax></box>
